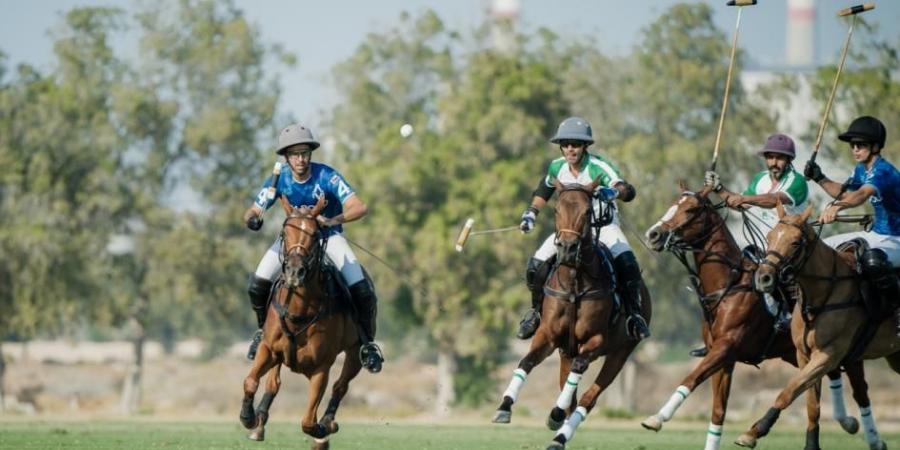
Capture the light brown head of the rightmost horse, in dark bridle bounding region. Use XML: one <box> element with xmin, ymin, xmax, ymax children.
<box><xmin>753</xmin><ymin>200</ymin><xmax>817</xmax><ymax>292</ymax></box>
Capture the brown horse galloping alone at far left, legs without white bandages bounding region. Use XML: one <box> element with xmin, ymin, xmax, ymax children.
<box><xmin>240</xmin><ymin>197</ymin><xmax>362</xmax><ymax>449</ymax></box>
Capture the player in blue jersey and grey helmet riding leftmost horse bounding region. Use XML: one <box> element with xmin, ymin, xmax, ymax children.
<box><xmin>244</xmin><ymin>124</ymin><xmax>384</xmax><ymax>373</ymax></box>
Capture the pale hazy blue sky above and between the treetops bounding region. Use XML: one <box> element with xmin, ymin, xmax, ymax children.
<box><xmin>0</xmin><ymin>0</ymin><xmax>900</xmax><ymax>126</ymax></box>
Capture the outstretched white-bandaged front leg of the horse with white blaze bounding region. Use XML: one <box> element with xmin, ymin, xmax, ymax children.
<box><xmin>641</xmin><ymin>337</ymin><xmax>734</xmax><ymax>431</ymax></box>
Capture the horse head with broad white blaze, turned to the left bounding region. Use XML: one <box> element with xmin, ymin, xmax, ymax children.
<box><xmin>645</xmin><ymin>181</ymin><xmax>721</xmax><ymax>252</ymax></box>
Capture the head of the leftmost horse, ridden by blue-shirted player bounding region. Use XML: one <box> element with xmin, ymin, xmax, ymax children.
<box><xmin>281</xmin><ymin>196</ymin><xmax>325</xmax><ymax>288</ymax></box>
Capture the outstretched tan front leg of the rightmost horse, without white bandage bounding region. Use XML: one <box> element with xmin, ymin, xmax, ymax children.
<box><xmin>734</xmin><ymin>350</ymin><xmax>849</xmax><ymax>448</ymax></box>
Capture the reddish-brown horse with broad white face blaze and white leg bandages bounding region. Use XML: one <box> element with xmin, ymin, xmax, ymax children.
<box><xmin>641</xmin><ymin>183</ymin><xmax>864</xmax><ymax>450</ymax></box>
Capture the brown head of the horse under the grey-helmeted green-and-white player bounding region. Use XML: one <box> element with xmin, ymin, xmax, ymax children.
<box><xmin>553</xmin><ymin>179</ymin><xmax>600</xmax><ymax>266</ymax></box>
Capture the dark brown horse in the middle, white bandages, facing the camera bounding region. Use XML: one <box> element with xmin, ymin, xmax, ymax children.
<box><xmin>493</xmin><ymin>180</ymin><xmax>651</xmax><ymax>449</ymax></box>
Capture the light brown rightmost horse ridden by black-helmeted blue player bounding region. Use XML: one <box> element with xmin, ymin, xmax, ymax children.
<box><xmin>735</xmin><ymin>203</ymin><xmax>900</xmax><ymax>450</ymax></box>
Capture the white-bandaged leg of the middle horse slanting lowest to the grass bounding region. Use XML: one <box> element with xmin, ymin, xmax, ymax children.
<box><xmin>547</xmin><ymin>343</ymin><xmax>637</xmax><ymax>450</ymax></box>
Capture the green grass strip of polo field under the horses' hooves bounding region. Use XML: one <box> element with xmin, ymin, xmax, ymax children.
<box><xmin>0</xmin><ymin>418</ymin><xmax>900</xmax><ymax>450</ymax></box>
